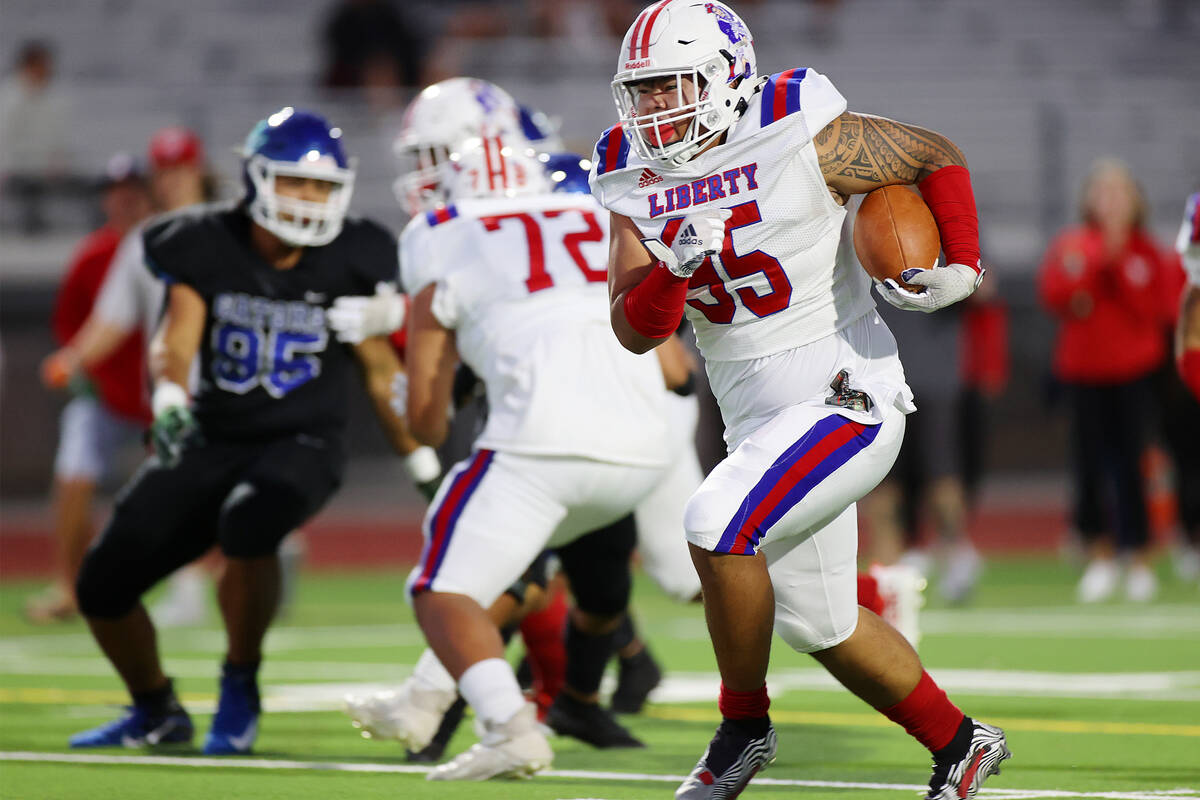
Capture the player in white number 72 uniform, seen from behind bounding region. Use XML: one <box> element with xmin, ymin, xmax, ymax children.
<box><xmin>401</xmin><ymin>104</ymin><xmax>670</xmax><ymax>780</ymax></box>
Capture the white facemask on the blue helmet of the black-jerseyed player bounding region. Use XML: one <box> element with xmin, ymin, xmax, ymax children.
<box><xmin>246</xmin><ymin>155</ymin><xmax>354</xmax><ymax>247</ymax></box>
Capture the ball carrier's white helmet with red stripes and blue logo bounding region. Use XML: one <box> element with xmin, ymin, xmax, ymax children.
<box><xmin>612</xmin><ymin>0</ymin><xmax>757</xmax><ymax>168</ymax></box>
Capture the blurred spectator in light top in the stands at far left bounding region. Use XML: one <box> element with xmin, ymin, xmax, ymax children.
<box><xmin>0</xmin><ymin>41</ymin><xmax>77</xmax><ymax>234</ymax></box>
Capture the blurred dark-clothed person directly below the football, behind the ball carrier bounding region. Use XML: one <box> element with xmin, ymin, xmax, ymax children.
<box><xmin>862</xmin><ymin>303</ymin><xmax>982</xmax><ymax>603</ymax></box>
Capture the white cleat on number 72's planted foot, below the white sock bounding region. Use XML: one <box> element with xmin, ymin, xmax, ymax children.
<box><xmin>425</xmin><ymin>703</ymin><xmax>554</xmax><ymax>781</ymax></box>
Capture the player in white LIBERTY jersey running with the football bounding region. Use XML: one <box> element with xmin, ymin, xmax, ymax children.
<box><xmin>592</xmin><ymin>0</ymin><xmax>1009</xmax><ymax>800</ymax></box>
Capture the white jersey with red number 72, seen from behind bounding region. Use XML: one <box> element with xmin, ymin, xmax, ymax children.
<box><xmin>400</xmin><ymin>194</ymin><xmax>670</xmax><ymax>467</ymax></box>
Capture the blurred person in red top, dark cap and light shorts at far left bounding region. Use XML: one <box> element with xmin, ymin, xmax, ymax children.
<box><xmin>25</xmin><ymin>154</ymin><xmax>151</xmax><ymax>622</ymax></box>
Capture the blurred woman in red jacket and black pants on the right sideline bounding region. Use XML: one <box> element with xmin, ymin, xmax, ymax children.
<box><xmin>1038</xmin><ymin>158</ymin><xmax>1169</xmax><ymax>602</ymax></box>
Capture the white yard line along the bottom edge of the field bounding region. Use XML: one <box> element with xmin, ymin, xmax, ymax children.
<box><xmin>0</xmin><ymin>751</ymin><xmax>1200</xmax><ymax>800</ymax></box>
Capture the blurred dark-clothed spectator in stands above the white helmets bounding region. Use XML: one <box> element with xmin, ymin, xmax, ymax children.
<box><xmin>322</xmin><ymin>0</ymin><xmax>430</xmax><ymax>89</ymax></box>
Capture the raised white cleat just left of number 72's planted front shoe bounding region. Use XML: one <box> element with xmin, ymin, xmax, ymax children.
<box><xmin>346</xmin><ymin>678</ymin><xmax>457</xmax><ymax>752</ymax></box>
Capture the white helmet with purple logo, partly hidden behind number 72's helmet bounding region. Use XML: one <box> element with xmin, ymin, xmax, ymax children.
<box><xmin>392</xmin><ymin>78</ymin><xmax>521</xmax><ymax>216</ymax></box>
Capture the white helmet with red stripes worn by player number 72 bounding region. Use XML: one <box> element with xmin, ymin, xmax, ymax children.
<box><xmin>440</xmin><ymin>133</ymin><xmax>553</xmax><ymax>203</ymax></box>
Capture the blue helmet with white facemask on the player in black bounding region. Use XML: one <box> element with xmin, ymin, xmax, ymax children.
<box><xmin>242</xmin><ymin>106</ymin><xmax>354</xmax><ymax>247</ymax></box>
